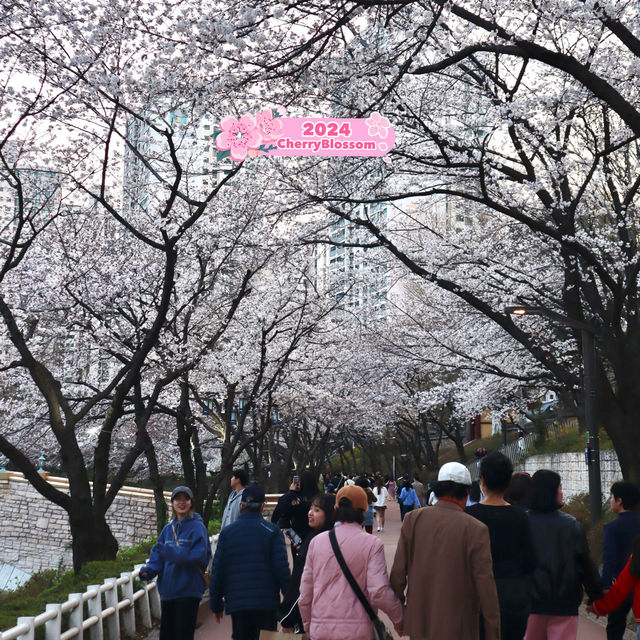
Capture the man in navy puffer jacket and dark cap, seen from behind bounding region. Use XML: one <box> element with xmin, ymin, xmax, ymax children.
<box><xmin>209</xmin><ymin>485</ymin><xmax>290</xmax><ymax>640</ymax></box>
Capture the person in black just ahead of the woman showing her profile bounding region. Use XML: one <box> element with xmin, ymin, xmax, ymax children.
<box><xmin>271</xmin><ymin>471</ymin><xmax>318</xmax><ymax>557</ymax></box>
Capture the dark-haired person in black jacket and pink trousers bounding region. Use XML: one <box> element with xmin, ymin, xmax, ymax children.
<box><xmin>525</xmin><ymin>469</ymin><xmax>603</xmax><ymax>640</ymax></box>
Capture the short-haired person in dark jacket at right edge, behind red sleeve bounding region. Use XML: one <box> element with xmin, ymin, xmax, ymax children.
<box><xmin>602</xmin><ymin>482</ymin><xmax>640</xmax><ymax>640</ymax></box>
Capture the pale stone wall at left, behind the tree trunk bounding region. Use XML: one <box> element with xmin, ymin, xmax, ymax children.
<box><xmin>0</xmin><ymin>479</ymin><xmax>165</xmax><ymax>573</ymax></box>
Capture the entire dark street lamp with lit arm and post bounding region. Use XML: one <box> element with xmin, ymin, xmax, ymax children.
<box><xmin>504</xmin><ymin>305</ymin><xmax>602</xmax><ymax>523</ymax></box>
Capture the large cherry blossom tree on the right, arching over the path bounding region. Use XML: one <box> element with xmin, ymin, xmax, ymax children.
<box><xmin>219</xmin><ymin>0</ymin><xmax>640</xmax><ymax>478</ymax></box>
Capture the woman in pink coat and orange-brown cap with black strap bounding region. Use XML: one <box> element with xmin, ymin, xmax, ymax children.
<box><xmin>298</xmin><ymin>486</ymin><xmax>402</xmax><ymax>640</ymax></box>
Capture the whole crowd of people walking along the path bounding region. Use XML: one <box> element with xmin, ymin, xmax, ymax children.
<box><xmin>140</xmin><ymin>452</ymin><xmax>640</xmax><ymax>640</ymax></box>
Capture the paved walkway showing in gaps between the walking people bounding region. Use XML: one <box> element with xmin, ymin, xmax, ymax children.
<box><xmin>142</xmin><ymin>502</ymin><xmax>635</xmax><ymax>640</ymax></box>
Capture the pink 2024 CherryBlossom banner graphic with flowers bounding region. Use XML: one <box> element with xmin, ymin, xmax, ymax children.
<box><xmin>216</xmin><ymin>107</ymin><xmax>396</xmax><ymax>162</ymax></box>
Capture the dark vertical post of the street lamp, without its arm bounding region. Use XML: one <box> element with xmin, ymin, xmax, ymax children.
<box><xmin>582</xmin><ymin>329</ymin><xmax>602</xmax><ymax>524</ymax></box>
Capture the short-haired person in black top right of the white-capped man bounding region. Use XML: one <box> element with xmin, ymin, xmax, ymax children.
<box><xmin>466</xmin><ymin>451</ymin><xmax>536</xmax><ymax>640</ymax></box>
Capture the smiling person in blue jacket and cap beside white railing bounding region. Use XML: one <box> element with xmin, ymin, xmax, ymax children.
<box><xmin>140</xmin><ymin>486</ymin><xmax>211</xmax><ymax>640</ymax></box>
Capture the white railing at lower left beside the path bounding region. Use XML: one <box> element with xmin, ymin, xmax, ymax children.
<box><xmin>0</xmin><ymin>565</ymin><xmax>160</xmax><ymax>640</ymax></box>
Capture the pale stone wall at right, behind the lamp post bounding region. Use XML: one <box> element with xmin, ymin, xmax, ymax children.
<box><xmin>518</xmin><ymin>449</ymin><xmax>622</xmax><ymax>500</ymax></box>
